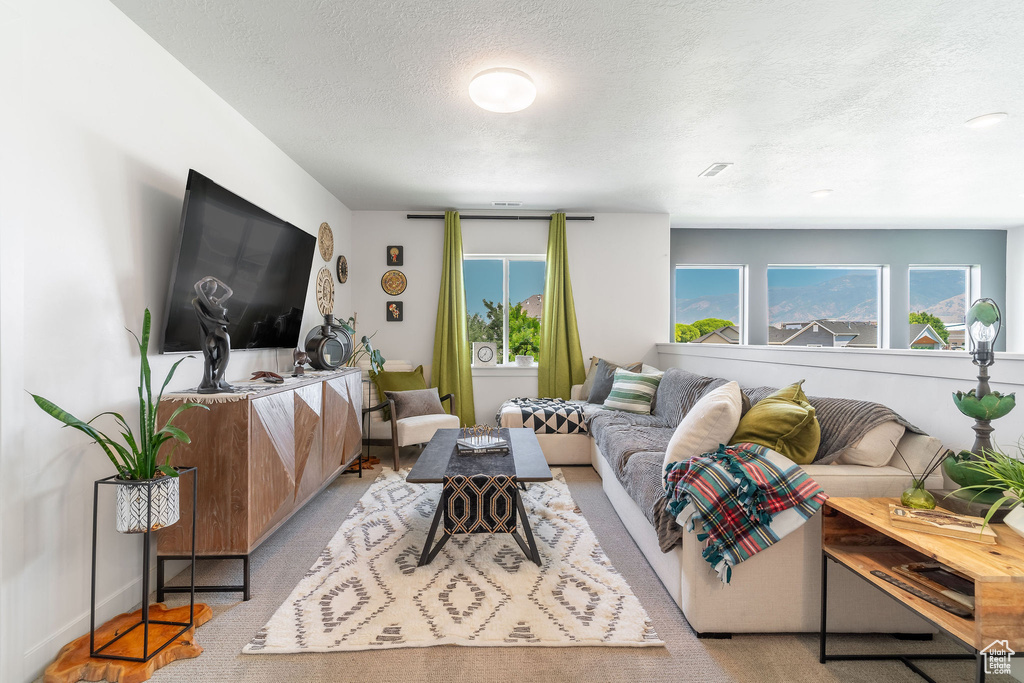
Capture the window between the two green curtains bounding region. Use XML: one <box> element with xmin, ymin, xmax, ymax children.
<box><xmin>462</xmin><ymin>255</ymin><xmax>545</xmax><ymax>362</ymax></box>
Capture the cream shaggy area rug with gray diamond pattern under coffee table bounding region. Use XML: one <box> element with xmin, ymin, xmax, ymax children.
<box><xmin>243</xmin><ymin>469</ymin><xmax>665</xmax><ymax>654</ymax></box>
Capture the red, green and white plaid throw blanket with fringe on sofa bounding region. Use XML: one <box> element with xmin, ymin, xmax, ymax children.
<box><xmin>665</xmin><ymin>443</ymin><xmax>828</xmax><ymax>583</ymax></box>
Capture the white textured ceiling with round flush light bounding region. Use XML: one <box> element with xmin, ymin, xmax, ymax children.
<box><xmin>114</xmin><ymin>0</ymin><xmax>1024</xmax><ymax>227</ymax></box>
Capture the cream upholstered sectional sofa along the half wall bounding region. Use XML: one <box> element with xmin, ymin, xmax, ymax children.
<box><xmin>538</xmin><ymin>369</ymin><xmax>941</xmax><ymax>636</ymax></box>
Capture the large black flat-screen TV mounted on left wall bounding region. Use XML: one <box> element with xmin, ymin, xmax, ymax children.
<box><xmin>161</xmin><ymin>170</ymin><xmax>316</xmax><ymax>353</ymax></box>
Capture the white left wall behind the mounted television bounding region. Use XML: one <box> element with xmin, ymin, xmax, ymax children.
<box><xmin>0</xmin><ymin>0</ymin><xmax>351</xmax><ymax>681</ymax></box>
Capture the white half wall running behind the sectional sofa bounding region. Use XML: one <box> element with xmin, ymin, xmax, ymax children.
<box><xmin>657</xmin><ymin>344</ymin><xmax>1024</xmax><ymax>451</ymax></box>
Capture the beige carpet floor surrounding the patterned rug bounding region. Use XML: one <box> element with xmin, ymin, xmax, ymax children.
<box><xmin>130</xmin><ymin>448</ymin><xmax>1014</xmax><ymax>683</ymax></box>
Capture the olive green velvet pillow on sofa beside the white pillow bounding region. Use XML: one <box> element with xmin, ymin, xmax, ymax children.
<box><xmin>731</xmin><ymin>380</ymin><xmax>821</xmax><ymax>465</ymax></box>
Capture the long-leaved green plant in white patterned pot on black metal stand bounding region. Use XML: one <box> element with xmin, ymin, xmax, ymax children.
<box><xmin>32</xmin><ymin>308</ymin><xmax>210</xmax><ymax>533</ymax></box>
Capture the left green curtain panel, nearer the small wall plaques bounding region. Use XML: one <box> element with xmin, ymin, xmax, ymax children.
<box><xmin>430</xmin><ymin>211</ymin><xmax>476</xmax><ymax>427</ymax></box>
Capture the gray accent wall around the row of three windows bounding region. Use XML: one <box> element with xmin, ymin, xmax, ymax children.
<box><xmin>669</xmin><ymin>228</ymin><xmax>1007</xmax><ymax>351</ymax></box>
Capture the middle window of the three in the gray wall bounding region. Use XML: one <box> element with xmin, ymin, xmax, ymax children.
<box><xmin>768</xmin><ymin>265</ymin><xmax>882</xmax><ymax>348</ymax></box>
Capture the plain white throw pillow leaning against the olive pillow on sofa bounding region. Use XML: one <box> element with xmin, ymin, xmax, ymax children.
<box><xmin>665</xmin><ymin>382</ymin><xmax>743</xmax><ymax>475</ymax></box>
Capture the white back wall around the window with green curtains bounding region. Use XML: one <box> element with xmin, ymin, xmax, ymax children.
<box><xmin>349</xmin><ymin>211</ymin><xmax>670</xmax><ymax>422</ymax></box>
